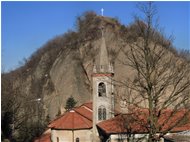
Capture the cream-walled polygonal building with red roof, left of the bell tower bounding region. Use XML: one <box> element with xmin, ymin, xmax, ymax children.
<box><xmin>48</xmin><ymin>103</ymin><xmax>92</xmax><ymax>142</ymax></box>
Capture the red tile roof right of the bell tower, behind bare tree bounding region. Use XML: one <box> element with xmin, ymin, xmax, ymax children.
<box><xmin>97</xmin><ymin>109</ymin><xmax>190</xmax><ymax>134</ymax></box>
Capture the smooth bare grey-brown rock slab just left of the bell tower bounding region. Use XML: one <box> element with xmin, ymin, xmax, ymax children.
<box><xmin>47</xmin><ymin>48</ymin><xmax>92</xmax><ymax>116</ymax></box>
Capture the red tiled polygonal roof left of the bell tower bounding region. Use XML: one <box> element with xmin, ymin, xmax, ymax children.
<box><xmin>48</xmin><ymin>103</ymin><xmax>92</xmax><ymax>130</ymax></box>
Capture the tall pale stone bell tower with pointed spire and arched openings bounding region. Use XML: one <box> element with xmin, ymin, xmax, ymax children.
<box><xmin>92</xmin><ymin>27</ymin><xmax>114</xmax><ymax>141</ymax></box>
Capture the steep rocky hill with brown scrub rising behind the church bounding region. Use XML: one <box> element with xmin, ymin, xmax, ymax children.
<box><xmin>2</xmin><ymin>12</ymin><xmax>189</xmax><ymax>119</ymax></box>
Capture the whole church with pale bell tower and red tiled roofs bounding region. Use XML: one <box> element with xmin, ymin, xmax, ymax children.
<box><xmin>35</xmin><ymin>24</ymin><xmax>190</xmax><ymax>142</ymax></box>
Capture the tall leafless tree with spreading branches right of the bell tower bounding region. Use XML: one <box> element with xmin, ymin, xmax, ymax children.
<box><xmin>116</xmin><ymin>2</ymin><xmax>190</xmax><ymax>142</ymax></box>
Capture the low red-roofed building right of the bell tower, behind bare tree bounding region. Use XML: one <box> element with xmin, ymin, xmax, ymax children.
<box><xmin>97</xmin><ymin>109</ymin><xmax>190</xmax><ymax>142</ymax></box>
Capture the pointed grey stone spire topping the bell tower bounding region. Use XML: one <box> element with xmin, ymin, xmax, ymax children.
<box><xmin>94</xmin><ymin>27</ymin><xmax>113</xmax><ymax>73</ymax></box>
